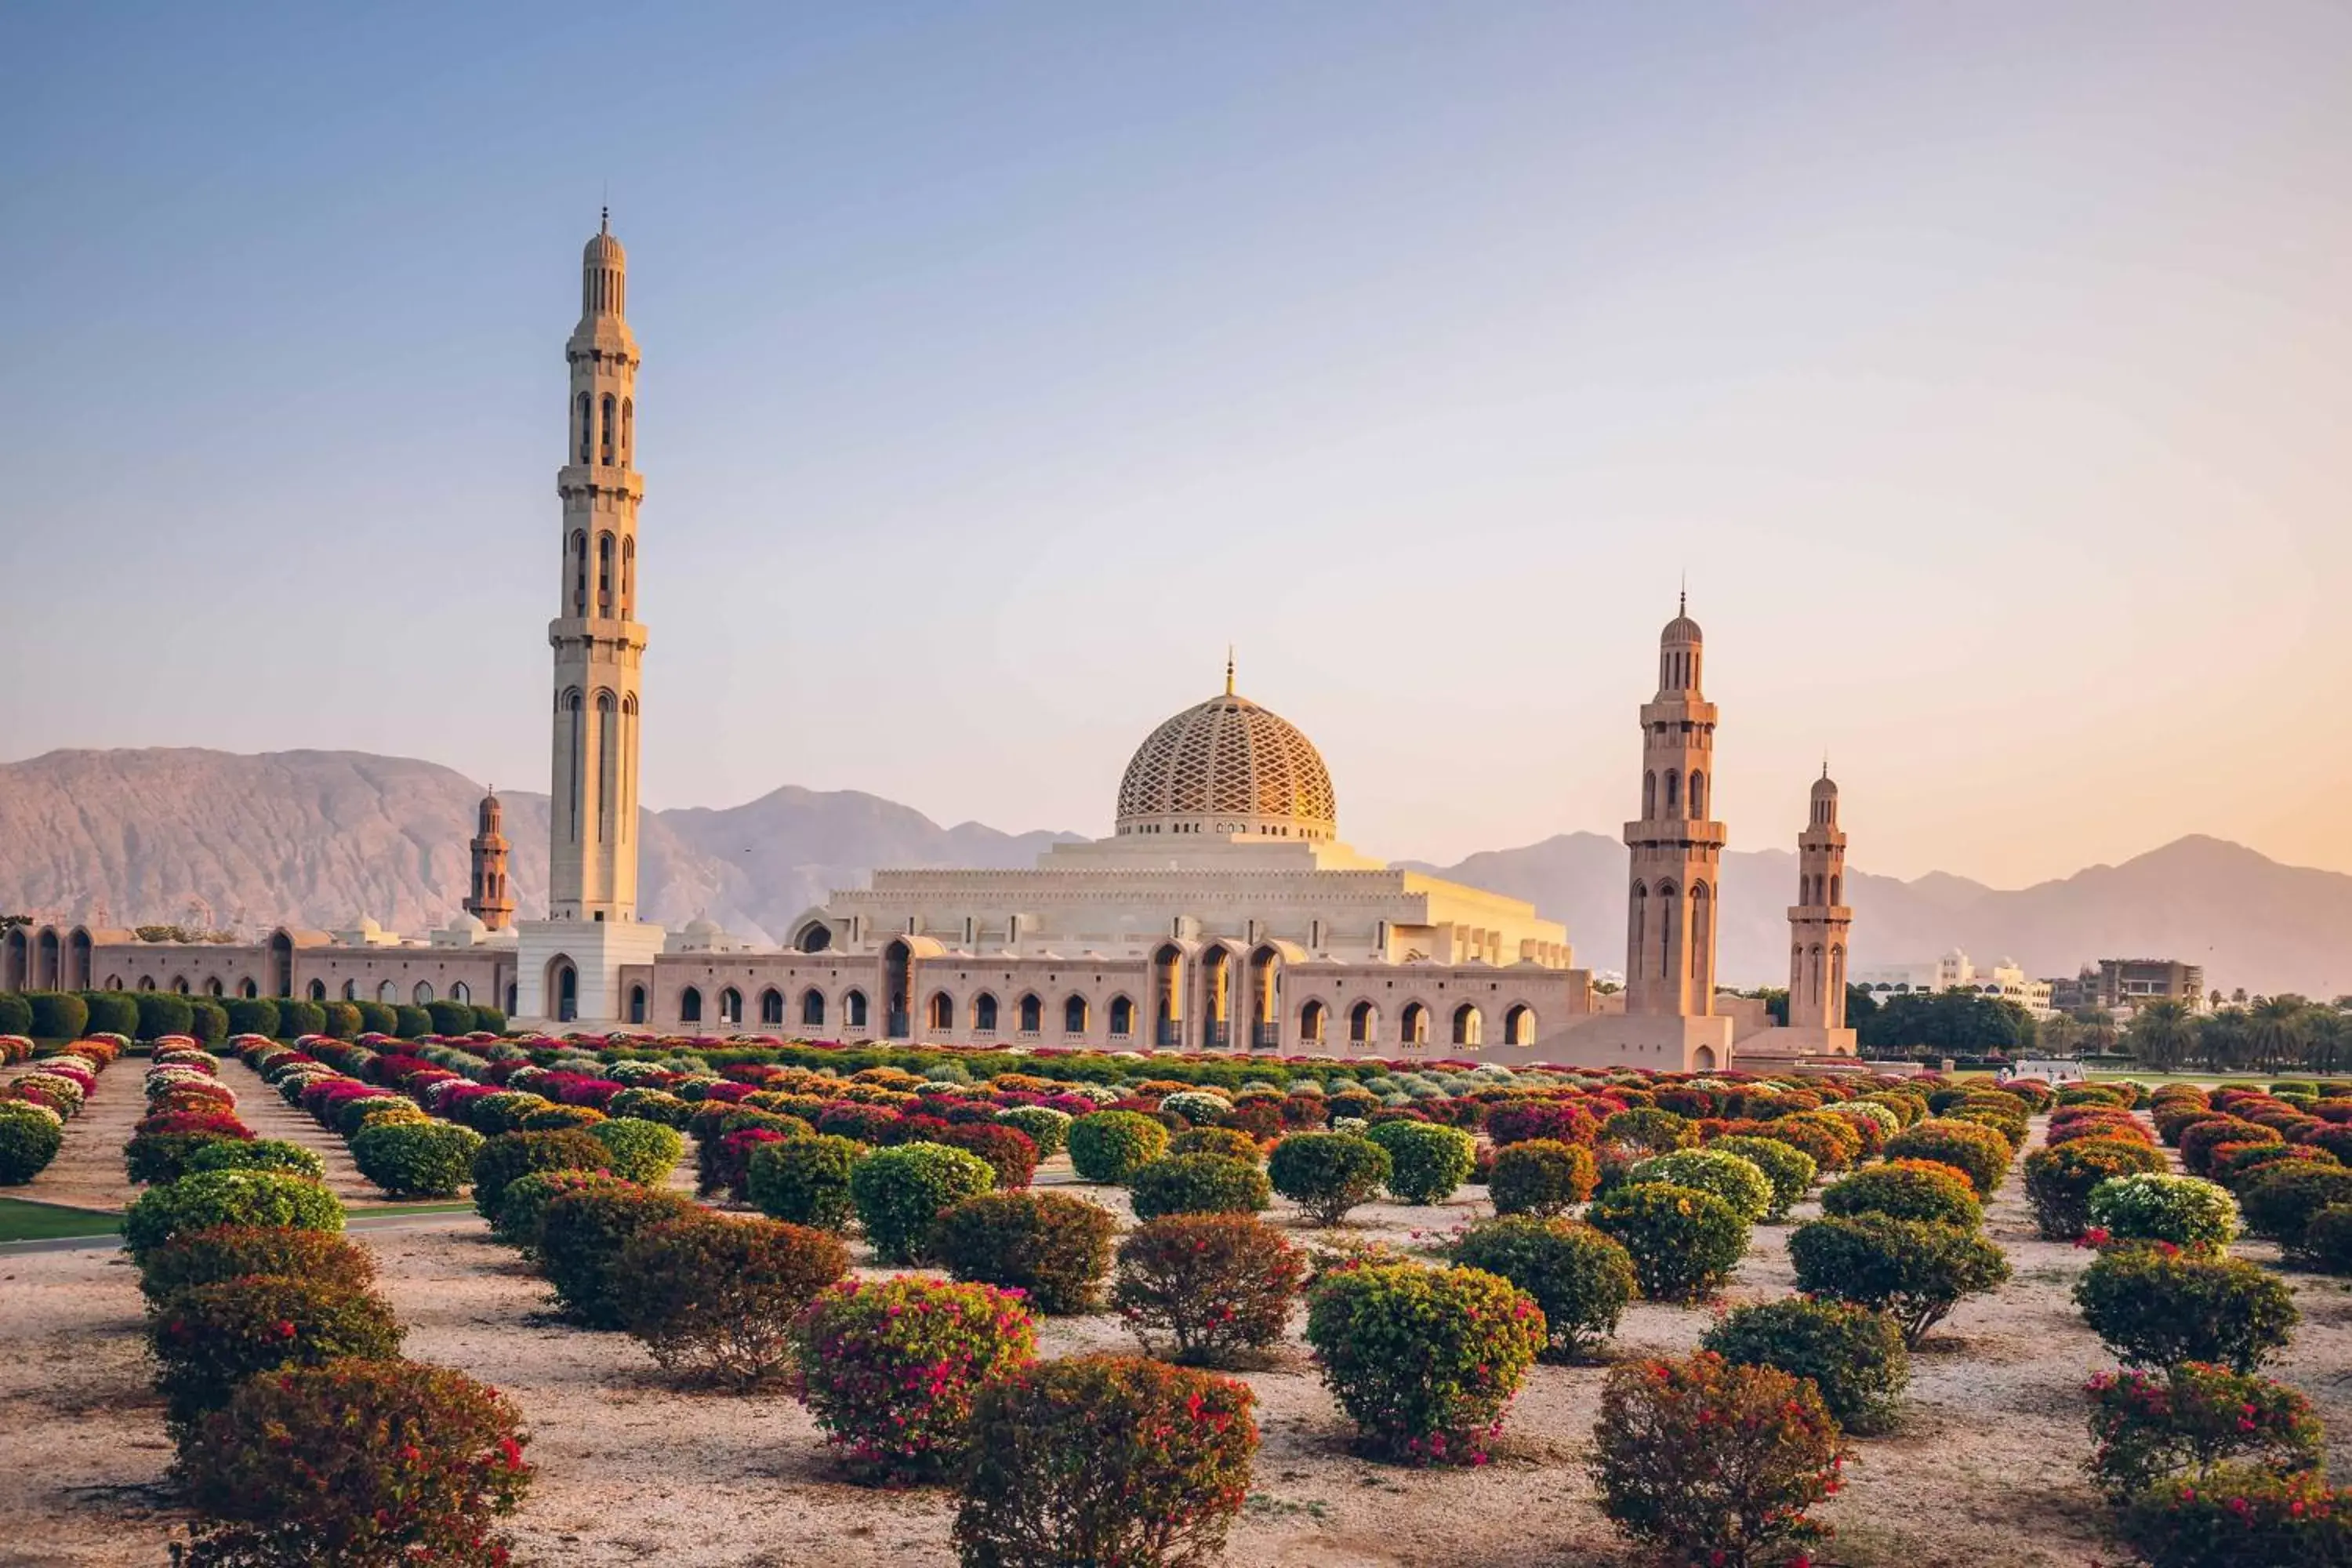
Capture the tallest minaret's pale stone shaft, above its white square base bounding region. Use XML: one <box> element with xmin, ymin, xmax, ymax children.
<box><xmin>548</xmin><ymin>212</ymin><xmax>644</xmax><ymax>921</ymax></box>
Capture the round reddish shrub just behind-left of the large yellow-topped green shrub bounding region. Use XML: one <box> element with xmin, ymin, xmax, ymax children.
<box><xmin>1110</xmin><ymin>1213</ymin><xmax>1308</xmax><ymax>1366</ymax></box>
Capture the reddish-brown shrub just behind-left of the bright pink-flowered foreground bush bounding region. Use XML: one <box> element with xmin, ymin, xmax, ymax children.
<box><xmin>616</xmin><ymin>1213</ymin><xmax>849</xmax><ymax>1389</ymax></box>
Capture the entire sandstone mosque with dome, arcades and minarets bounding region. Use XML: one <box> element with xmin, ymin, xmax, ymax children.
<box><xmin>0</xmin><ymin>223</ymin><xmax>1853</xmax><ymax>1072</ymax></box>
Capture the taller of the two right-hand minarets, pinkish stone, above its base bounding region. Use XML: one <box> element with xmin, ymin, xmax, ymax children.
<box><xmin>1625</xmin><ymin>597</ymin><xmax>1724</xmax><ymax>1020</ymax></box>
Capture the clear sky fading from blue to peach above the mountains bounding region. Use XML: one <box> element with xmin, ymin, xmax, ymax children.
<box><xmin>0</xmin><ymin>0</ymin><xmax>2352</xmax><ymax>884</ymax></box>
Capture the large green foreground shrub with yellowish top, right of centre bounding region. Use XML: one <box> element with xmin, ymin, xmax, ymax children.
<box><xmin>1308</xmin><ymin>1262</ymin><xmax>1550</xmax><ymax>1465</ymax></box>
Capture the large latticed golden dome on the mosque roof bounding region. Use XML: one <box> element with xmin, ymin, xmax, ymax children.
<box><xmin>1117</xmin><ymin>689</ymin><xmax>1338</xmax><ymax>839</ymax></box>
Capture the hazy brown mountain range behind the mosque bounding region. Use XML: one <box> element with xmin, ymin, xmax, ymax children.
<box><xmin>0</xmin><ymin>748</ymin><xmax>2352</xmax><ymax>996</ymax></box>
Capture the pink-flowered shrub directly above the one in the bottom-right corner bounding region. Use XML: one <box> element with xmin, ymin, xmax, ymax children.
<box><xmin>2089</xmin><ymin>1361</ymin><xmax>2326</xmax><ymax>1502</ymax></box>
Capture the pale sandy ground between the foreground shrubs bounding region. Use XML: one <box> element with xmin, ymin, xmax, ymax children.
<box><xmin>0</xmin><ymin>1123</ymin><xmax>2352</xmax><ymax>1568</ymax></box>
